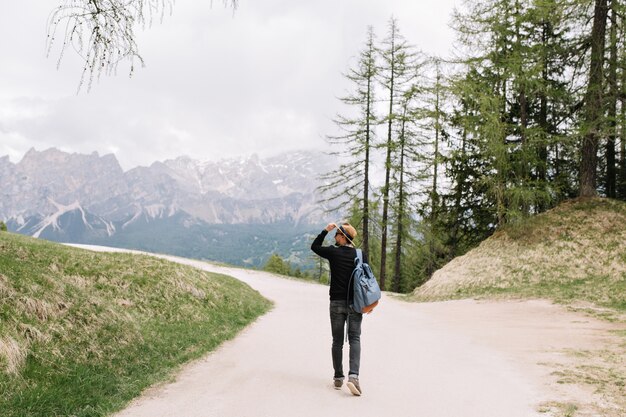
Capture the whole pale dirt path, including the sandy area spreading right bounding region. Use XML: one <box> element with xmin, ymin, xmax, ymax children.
<box><xmin>72</xmin><ymin>245</ymin><xmax>620</xmax><ymax>417</ymax></box>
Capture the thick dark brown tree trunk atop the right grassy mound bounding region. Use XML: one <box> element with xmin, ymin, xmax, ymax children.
<box><xmin>580</xmin><ymin>0</ymin><xmax>608</xmax><ymax>197</ymax></box>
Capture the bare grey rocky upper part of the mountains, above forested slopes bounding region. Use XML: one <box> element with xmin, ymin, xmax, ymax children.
<box><xmin>0</xmin><ymin>148</ymin><xmax>334</xmax><ymax>224</ymax></box>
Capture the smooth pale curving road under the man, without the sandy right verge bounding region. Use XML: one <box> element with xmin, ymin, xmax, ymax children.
<box><xmin>92</xmin><ymin>254</ymin><xmax>545</xmax><ymax>417</ymax></box>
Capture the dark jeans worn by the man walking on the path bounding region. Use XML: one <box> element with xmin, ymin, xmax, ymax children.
<box><xmin>330</xmin><ymin>300</ymin><xmax>363</xmax><ymax>379</ymax></box>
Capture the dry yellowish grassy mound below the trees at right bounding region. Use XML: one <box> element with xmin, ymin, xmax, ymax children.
<box><xmin>413</xmin><ymin>198</ymin><xmax>626</xmax><ymax>313</ymax></box>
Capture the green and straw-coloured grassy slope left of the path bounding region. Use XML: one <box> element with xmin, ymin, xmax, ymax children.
<box><xmin>0</xmin><ymin>232</ymin><xmax>270</xmax><ymax>417</ymax></box>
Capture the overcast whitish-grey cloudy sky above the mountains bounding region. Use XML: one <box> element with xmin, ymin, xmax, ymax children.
<box><xmin>0</xmin><ymin>0</ymin><xmax>460</xmax><ymax>170</ymax></box>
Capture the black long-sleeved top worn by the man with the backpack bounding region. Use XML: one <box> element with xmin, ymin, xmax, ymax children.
<box><xmin>311</xmin><ymin>229</ymin><xmax>367</xmax><ymax>300</ymax></box>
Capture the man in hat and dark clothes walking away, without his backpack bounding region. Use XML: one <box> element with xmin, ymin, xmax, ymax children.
<box><xmin>311</xmin><ymin>219</ymin><xmax>367</xmax><ymax>395</ymax></box>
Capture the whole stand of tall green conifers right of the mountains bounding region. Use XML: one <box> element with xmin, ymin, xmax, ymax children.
<box><xmin>321</xmin><ymin>0</ymin><xmax>626</xmax><ymax>292</ymax></box>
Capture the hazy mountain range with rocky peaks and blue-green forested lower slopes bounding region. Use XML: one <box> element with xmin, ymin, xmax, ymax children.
<box><xmin>0</xmin><ymin>148</ymin><xmax>336</xmax><ymax>267</ymax></box>
